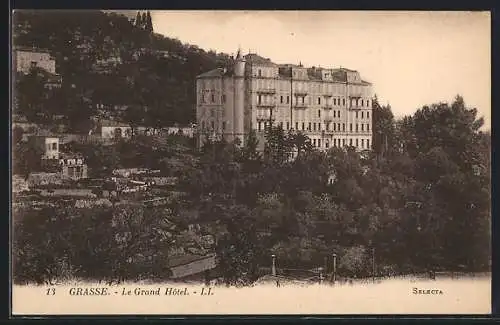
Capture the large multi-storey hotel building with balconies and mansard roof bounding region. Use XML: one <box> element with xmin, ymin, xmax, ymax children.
<box><xmin>196</xmin><ymin>52</ymin><xmax>373</xmax><ymax>150</ymax></box>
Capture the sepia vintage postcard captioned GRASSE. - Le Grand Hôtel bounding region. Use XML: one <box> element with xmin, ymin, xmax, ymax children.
<box><xmin>11</xmin><ymin>10</ymin><xmax>491</xmax><ymax>316</ymax></box>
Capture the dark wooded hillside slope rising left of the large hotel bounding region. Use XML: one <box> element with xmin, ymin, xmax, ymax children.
<box><xmin>13</xmin><ymin>10</ymin><xmax>234</xmax><ymax>127</ymax></box>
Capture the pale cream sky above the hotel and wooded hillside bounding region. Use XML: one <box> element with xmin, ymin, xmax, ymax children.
<box><xmin>146</xmin><ymin>11</ymin><xmax>491</xmax><ymax>128</ymax></box>
